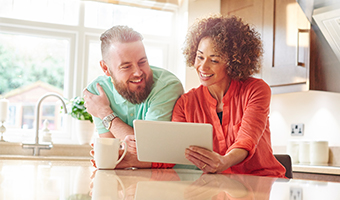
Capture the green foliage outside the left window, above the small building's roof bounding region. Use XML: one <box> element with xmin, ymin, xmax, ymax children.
<box><xmin>0</xmin><ymin>40</ymin><xmax>65</xmax><ymax>95</ymax></box>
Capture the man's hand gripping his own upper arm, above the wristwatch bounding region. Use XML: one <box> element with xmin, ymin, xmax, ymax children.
<box><xmin>83</xmin><ymin>83</ymin><xmax>113</xmax><ymax>119</ymax></box>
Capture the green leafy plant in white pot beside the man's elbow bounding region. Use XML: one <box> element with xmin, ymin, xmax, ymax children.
<box><xmin>67</xmin><ymin>96</ymin><xmax>95</xmax><ymax>144</ymax></box>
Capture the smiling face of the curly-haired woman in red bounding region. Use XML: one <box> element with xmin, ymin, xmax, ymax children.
<box><xmin>194</xmin><ymin>37</ymin><xmax>230</xmax><ymax>90</ymax></box>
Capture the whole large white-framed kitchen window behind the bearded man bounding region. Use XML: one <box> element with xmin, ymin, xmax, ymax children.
<box><xmin>0</xmin><ymin>0</ymin><xmax>176</xmax><ymax>144</ymax></box>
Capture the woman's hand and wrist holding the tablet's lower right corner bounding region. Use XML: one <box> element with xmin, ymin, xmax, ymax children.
<box><xmin>185</xmin><ymin>146</ymin><xmax>248</xmax><ymax>173</ymax></box>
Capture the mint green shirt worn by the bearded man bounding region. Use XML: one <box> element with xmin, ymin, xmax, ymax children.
<box><xmin>87</xmin><ymin>66</ymin><xmax>184</xmax><ymax>134</ymax></box>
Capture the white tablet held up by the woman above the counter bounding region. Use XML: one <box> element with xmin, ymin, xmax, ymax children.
<box><xmin>133</xmin><ymin>120</ymin><xmax>213</xmax><ymax>165</ymax></box>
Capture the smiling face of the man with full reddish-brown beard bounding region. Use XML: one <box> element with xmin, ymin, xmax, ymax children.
<box><xmin>100</xmin><ymin>41</ymin><xmax>153</xmax><ymax>104</ymax></box>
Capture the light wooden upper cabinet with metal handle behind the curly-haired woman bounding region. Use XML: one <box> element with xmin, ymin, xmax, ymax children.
<box><xmin>221</xmin><ymin>0</ymin><xmax>310</xmax><ymax>94</ymax></box>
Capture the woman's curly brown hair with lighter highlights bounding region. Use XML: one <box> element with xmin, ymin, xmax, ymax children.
<box><xmin>183</xmin><ymin>15</ymin><xmax>263</xmax><ymax>80</ymax></box>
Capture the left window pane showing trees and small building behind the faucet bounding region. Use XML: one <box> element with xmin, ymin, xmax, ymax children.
<box><xmin>0</xmin><ymin>31</ymin><xmax>70</xmax><ymax>142</ymax></box>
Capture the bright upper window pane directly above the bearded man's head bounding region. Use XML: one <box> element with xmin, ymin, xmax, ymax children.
<box><xmin>85</xmin><ymin>1</ymin><xmax>174</xmax><ymax>36</ymax></box>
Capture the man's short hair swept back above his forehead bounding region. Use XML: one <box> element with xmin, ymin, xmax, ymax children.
<box><xmin>100</xmin><ymin>25</ymin><xmax>143</xmax><ymax>59</ymax></box>
